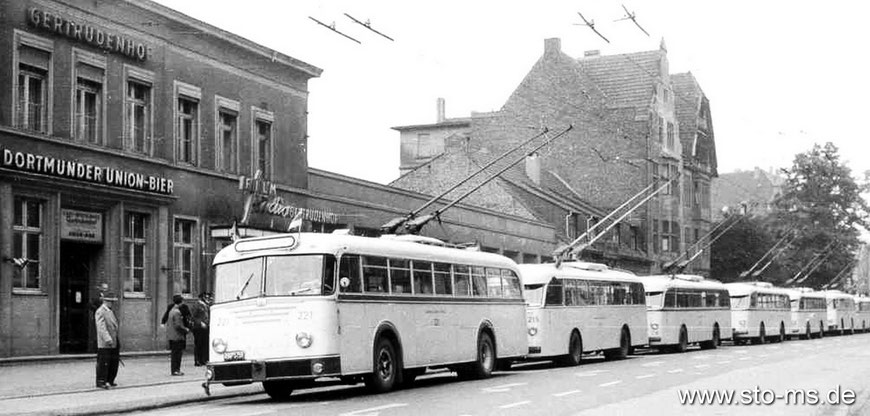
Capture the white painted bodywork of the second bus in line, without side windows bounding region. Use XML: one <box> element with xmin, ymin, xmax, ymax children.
<box><xmin>519</xmin><ymin>262</ymin><xmax>647</xmax><ymax>358</ymax></box>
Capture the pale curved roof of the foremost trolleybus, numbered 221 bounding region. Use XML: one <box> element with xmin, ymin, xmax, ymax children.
<box><xmin>213</xmin><ymin>233</ymin><xmax>516</xmax><ymax>270</ymax></box>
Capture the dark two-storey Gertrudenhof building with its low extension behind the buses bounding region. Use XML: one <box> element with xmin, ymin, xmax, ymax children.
<box><xmin>0</xmin><ymin>0</ymin><xmax>553</xmax><ymax>357</ymax></box>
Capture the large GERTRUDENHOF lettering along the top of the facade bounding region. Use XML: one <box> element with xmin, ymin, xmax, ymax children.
<box><xmin>27</xmin><ymin>7</ymin><xmax>148</xmax><ymax>61</ymax></box>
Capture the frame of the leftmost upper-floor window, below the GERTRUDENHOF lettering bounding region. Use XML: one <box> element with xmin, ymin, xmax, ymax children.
<box><xmin>9</xmin><ymin>29</ymin><xmax>54</xmax><ymax>135</ymax></box>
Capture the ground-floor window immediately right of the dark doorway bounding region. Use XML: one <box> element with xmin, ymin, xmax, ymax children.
<box><xmin>123</xmin><ymin>212</ymin><xmax>148</xmax><ymax>294</ymax></box>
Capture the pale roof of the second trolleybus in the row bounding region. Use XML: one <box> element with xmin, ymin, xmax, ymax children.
<box><xmin>517</xmin><ymin>261</ymin><xmax>641</xmax><ymax>285</ymax></box>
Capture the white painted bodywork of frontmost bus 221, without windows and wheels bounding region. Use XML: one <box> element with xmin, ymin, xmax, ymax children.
<box><xmin>207</xmin><ymin>233</ymin><xmax>528</xmax><ymax>392</ymax></box>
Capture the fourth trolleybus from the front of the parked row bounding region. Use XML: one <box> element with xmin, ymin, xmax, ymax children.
<box><xmin>725</xmin><ymin>282</ymin><xmax>791</xmax><ymax>344</ymax></box>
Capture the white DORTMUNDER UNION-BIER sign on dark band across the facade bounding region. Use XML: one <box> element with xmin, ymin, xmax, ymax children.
<box><xmin>0</xmin><ymin>149</ymin><xmax>174</xmax><ymax>195</ymax></box>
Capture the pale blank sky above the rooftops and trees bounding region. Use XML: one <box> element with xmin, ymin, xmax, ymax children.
<box><xmin>158</xmin><ymin>0</ymin><xmax>870</xmax><ymax>183</ymax></box>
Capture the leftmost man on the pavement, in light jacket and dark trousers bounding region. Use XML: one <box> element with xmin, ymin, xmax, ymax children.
<box><xmin>94</xmin><ymin>292</ymin><xmax>121</xmax><ymax>390</ymax></box>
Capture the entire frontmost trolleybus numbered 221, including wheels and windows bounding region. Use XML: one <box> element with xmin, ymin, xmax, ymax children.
<box><xmin>204</xmin><ymin>233</ymin><xmax>528</xmax><ymax>398</ymax></box>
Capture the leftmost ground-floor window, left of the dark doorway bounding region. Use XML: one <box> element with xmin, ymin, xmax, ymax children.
<box><xmin>12</xmin><ymin>197</ymin><xmax>44</xmax><ymax>290</ymax></box>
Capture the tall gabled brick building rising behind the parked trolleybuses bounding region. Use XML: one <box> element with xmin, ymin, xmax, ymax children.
<box><xmin>393</xmin><ymin>39</ymin><xmax>716</xmax><ymax>273</ymax></box>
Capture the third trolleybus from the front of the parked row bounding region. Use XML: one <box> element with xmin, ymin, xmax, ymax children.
<box><xmin>642</xmin><ymin>274</ymin><xmax>732</xmax><ymax>352</ymax></box>
